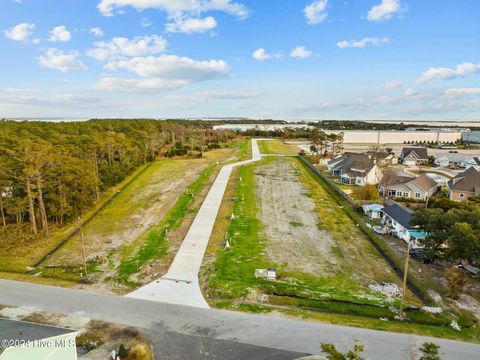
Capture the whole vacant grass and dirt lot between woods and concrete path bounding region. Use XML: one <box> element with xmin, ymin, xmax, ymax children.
<box><xmin>0</xmin><ymin>141</ymin><xmax>244</xmax><ymax>291</ymax></box>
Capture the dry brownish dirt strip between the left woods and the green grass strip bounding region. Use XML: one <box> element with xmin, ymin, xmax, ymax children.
<box><xmin>46</xmin><ymin>160</ymin><xmax>203</xmax><ymax>265</ymax></box>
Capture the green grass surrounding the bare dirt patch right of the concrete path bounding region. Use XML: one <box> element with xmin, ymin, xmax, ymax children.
<box><xmin>204</xmin><ymin>158</ymin><xmax>410</xmax><ymax>306</ymax></box>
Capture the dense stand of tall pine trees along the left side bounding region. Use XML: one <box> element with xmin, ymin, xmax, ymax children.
<box><xmin>0</xmin><ymin>119</ymin><xmax>235</xmax><ymax>237</ymax></box>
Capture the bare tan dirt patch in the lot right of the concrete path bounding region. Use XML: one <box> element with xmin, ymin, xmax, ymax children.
<box><xmin>253</xmin><ymin>158</ymin><xmax>338</xmax><ymax>275</ymax></box>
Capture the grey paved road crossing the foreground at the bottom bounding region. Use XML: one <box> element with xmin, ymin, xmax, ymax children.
<box><xmin>0</xmin><ymin>280</ymin><xmax>480</xmax><ymax>360</ymax></box>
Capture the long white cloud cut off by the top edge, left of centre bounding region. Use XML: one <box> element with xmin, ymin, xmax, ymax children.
<box><xmin>97</xmin><ymin>0</ymin><xmax>248</xmax><ymax>18</ymax></box>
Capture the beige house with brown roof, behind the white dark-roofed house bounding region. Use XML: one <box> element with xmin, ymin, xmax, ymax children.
<box><xmin>378</xmin><ymin>174</ymin><xmax>438</xmax><ymax>200</ymax></box>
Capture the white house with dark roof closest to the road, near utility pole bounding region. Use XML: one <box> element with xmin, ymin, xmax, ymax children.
<box><xmin>381</xmin><ymin>200</ymin><xmax>426</xmax><ymax>247</ymax></box>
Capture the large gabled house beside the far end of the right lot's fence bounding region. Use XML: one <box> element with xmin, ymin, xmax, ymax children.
<box><xmin>327</xmin><ymin>153</ymin><xmax>382</xmax><ymax>186</ymax></box>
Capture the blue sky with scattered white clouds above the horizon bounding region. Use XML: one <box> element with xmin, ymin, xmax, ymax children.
<box><xmin>0</xmin><ymin>0</ymin><xmax>480</xmax><ymax>120</ymax></box>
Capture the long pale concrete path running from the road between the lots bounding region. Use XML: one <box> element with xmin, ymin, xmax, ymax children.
<box><xmin>126</xmin><ymin>139</ymin><xmax>268</xmax><ymax>308</ymax></box>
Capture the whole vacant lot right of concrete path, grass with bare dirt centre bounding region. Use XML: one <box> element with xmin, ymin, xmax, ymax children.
<box><xmin>204</xmin><ymin>158</ymin><xmax>419</xmax><ymax>305</ymax></box>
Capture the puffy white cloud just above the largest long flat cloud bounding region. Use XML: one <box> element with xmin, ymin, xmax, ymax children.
<box><xmin>87</xmin><ymin>35</ymin><xmax>167</xmax><ymax>61</ymax></box>
